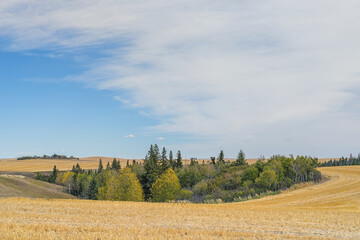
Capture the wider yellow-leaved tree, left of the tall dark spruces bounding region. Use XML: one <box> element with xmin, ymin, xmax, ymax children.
<box><xmin>99</xmin><ymin>167</ymin><xmax>144</xmax><ymax>202</ymax></box>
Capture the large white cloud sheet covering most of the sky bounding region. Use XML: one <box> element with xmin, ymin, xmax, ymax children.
<box><xmin>0</xmin><ymin>0</ymin><xmax>360</xmax><ymax>158</ymax></box>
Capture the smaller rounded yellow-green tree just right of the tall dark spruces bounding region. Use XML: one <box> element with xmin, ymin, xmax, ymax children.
<box><xmin>151</xmin><ymin>168</ymin><xmax>181</xmax><ymax>202</ymax></box>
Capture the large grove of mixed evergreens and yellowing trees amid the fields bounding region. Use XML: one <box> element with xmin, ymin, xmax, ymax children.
<box><xmin>37</xmin><ymin>144</ymin><xmax>321</xmax><ymax>202</ymax></box>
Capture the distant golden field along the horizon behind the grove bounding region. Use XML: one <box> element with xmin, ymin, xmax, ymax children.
<box><xmin>0</xmin><ymin>157</ymin><xmax>330</xmax><ymax>172</ymax></box>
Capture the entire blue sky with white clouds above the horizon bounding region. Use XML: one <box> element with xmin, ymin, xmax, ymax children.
<box><xmin>0</xmin><ymin>0</ymin><xmax>360</xmax><ymax>158</ymax></box>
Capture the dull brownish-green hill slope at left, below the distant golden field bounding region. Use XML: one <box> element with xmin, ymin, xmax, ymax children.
<box><xmin>0</xmin><ymin>174</ymin><xmax>75</xmax><ymax>199</ymax></box>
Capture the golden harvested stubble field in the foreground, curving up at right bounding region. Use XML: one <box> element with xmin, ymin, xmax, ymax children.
<box><xmin>0</xmin><ymin>166</ymin><xmax>360</xmax><ymax>239</ymax></box>
